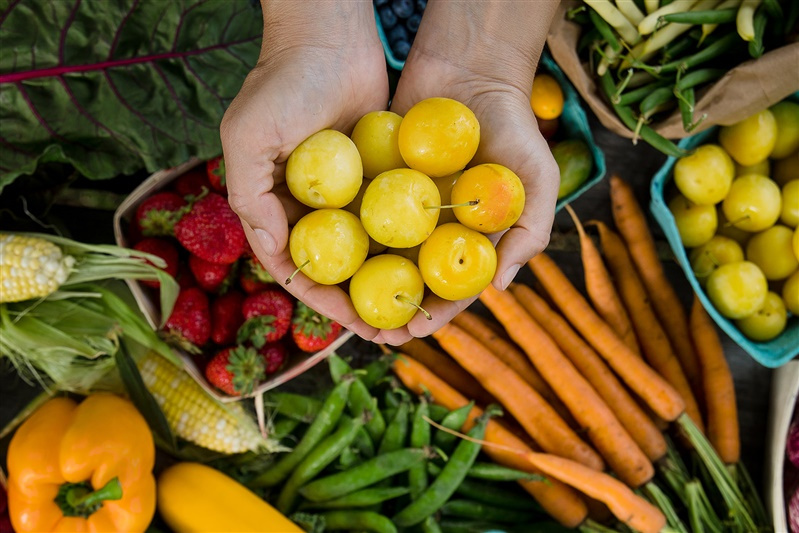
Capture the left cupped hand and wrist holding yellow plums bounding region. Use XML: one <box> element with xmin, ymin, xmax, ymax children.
<box><xmin>221</xmin><ymin>1</ymin><xmax>388</xmax><ymax>340</ymax></box>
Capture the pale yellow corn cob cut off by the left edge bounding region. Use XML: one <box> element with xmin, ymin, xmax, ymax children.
<box><xmin>0</xmin><ymin>233</ymin><xmax>75</xmax><ymax>303</ymax></box>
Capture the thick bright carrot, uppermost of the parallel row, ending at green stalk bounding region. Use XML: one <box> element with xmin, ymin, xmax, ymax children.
<box><xmin>527</xmin><ymin>253</ymin><xmax>685</xmax><ymax>422</ymax></box>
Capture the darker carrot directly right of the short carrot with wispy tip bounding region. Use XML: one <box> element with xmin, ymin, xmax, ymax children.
<box><xmin>592</xmin><ymin>222</ymin><xmax>703</xmax><ymax>430</ymax></box>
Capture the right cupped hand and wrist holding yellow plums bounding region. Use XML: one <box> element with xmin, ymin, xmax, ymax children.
<box><xmin>381</xmin><ymin>2</ymin><xmax>560</xmax><ymax>344</ymax></box>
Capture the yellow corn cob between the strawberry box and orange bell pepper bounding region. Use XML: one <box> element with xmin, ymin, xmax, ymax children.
<box><xmin>137</xmin><ymin>351</ymin><xmax>276</xmax><ymax>454</ymax></box>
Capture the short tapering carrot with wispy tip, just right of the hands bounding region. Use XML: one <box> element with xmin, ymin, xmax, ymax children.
<box><xmin>565</xmin><ymin>204</ymin><xmax>641</xmax><ymax>354</ymax></box>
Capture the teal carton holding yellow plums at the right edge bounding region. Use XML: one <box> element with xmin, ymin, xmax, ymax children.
<box><xmin>650</xmin><ymin>93</ymin><xmax>799</xmax><ymax>368</ymax></box>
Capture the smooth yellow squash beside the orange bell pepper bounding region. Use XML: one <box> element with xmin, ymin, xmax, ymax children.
<box><xmin>158</xmin><ymin>463</ymin><xmax>303</xmax><ymax>533</ymax></box>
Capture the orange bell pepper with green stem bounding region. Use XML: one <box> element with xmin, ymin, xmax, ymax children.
<box><xmin>7</xmin><ymin>393</ymin><xmax>155</xmax><ymax>533</ymax></box>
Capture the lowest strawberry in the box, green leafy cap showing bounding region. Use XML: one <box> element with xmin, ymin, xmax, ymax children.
<box><xmin>205</xmin><ymin>346</ymin><xmax>266</xmax><ymax>396</ymax></box>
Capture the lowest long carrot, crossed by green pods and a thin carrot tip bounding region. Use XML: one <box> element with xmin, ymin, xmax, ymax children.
<box><xmin>393</xmin><ymin>356</ymin><xmax>588</xmax><ymax>528</ymax></box>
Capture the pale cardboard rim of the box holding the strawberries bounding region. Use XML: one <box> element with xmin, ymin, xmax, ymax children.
<box><xmin>114</xmin><ymin>159</ymin><xmax>353</xmax><ymax>402</ymax></box>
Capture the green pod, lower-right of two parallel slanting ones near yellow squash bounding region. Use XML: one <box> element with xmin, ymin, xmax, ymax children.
<box><xmin>275</xmin><ymin>417</ymin><xmax>363</xmax><ymax>514</ymax></box>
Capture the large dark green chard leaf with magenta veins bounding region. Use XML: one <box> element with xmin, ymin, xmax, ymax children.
<box><xmin>0</xmin><ymin>0</ymin><xmax>263</xmax><ymax>191</ymax></box>
